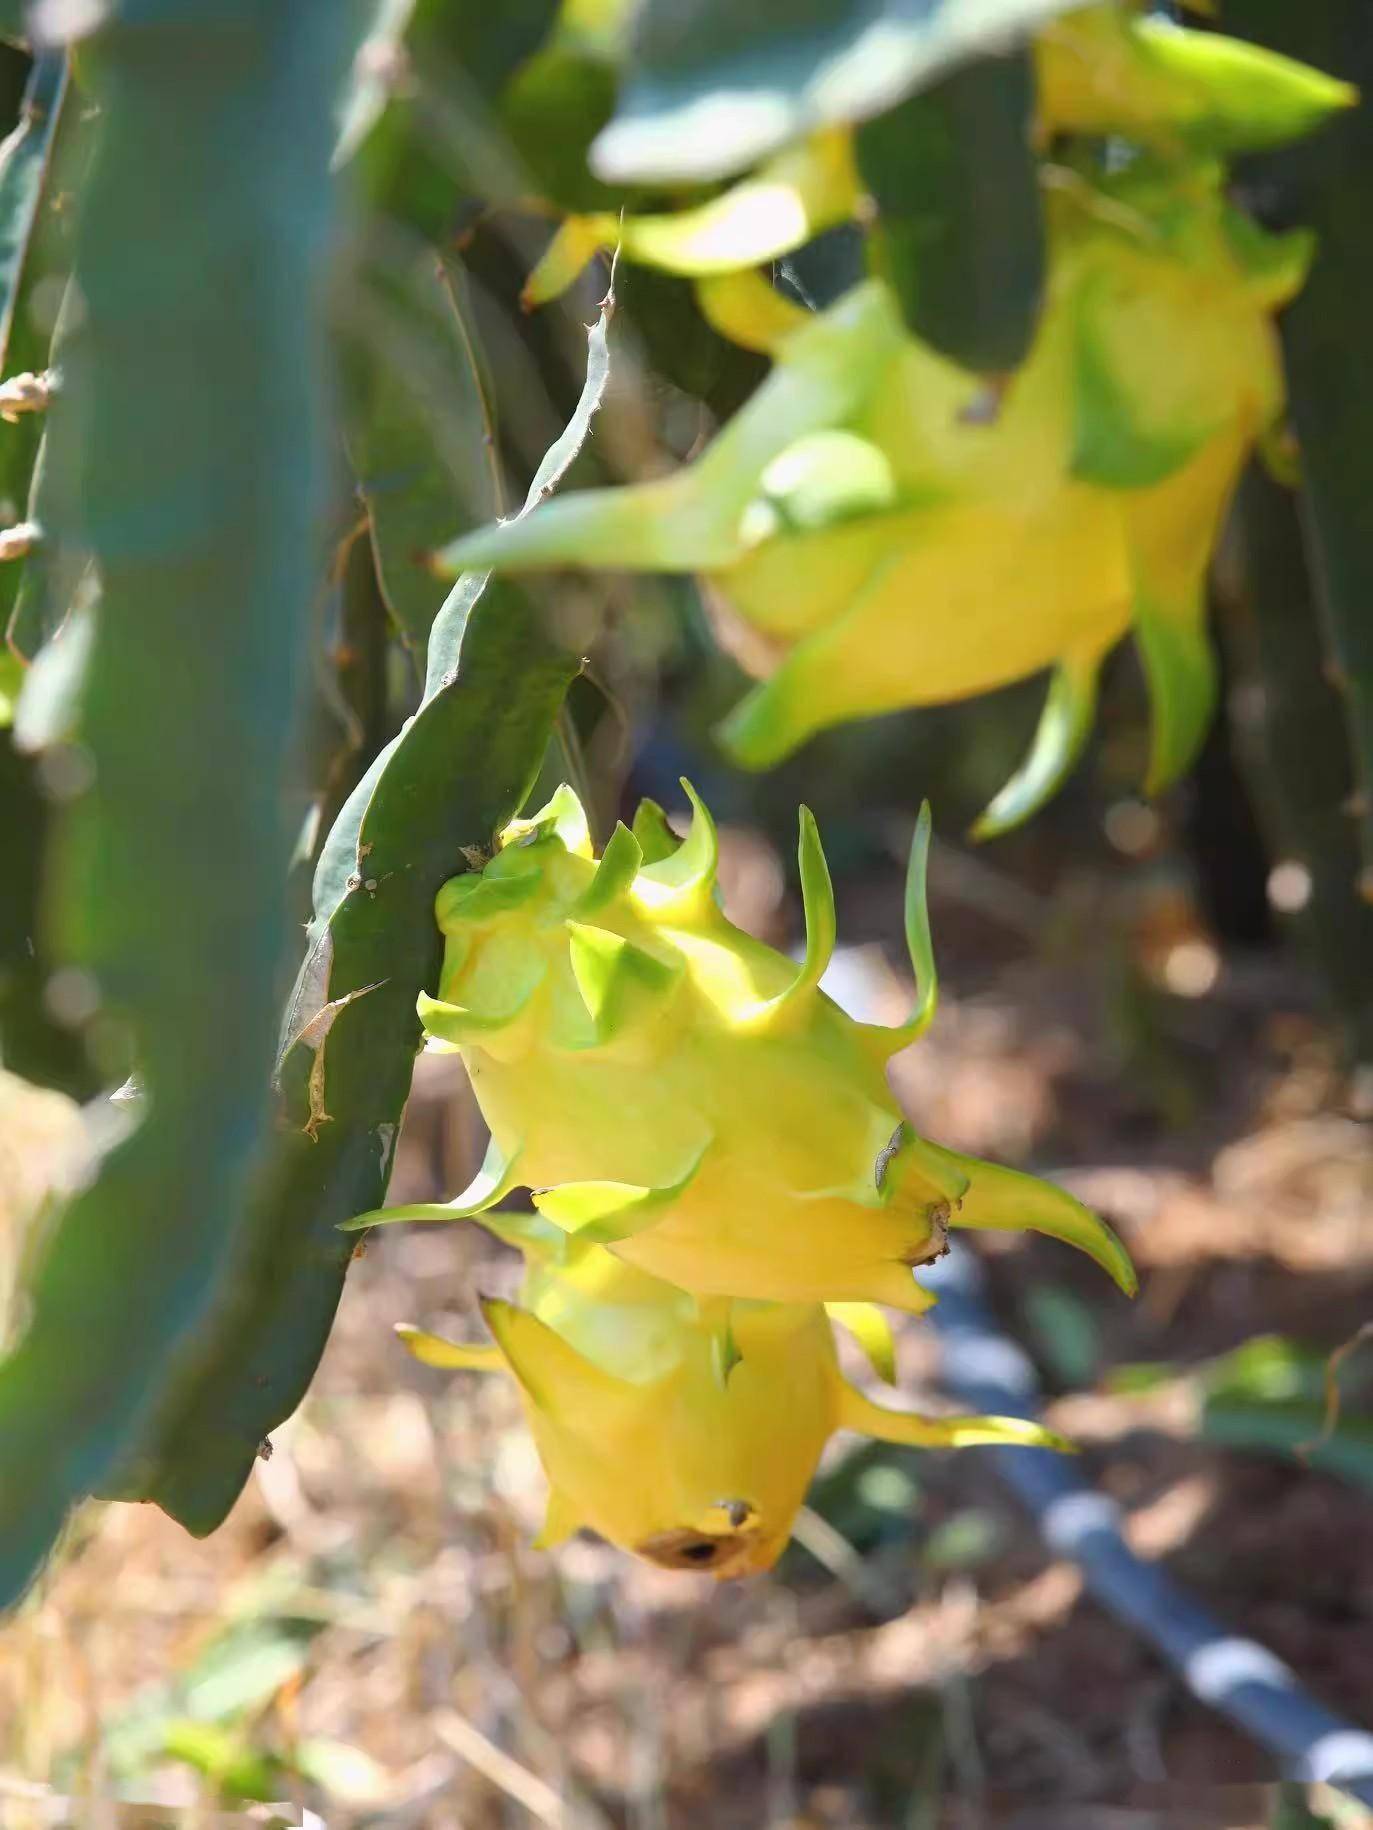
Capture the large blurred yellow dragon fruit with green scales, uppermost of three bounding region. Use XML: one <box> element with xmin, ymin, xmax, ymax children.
<box><xmin>445</xmin><ymin>159</ymin><xmax>1311</xmax><ymax>831</ymax></box>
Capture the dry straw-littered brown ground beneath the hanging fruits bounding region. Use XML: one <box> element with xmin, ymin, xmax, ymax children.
<box><xmin>0</xmin><ymin>838</ymin><xmax>1373</xmax><ymax>1830</ymax></box>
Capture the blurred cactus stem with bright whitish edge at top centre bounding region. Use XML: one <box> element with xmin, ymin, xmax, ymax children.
<box><xmin>591</xmin><ymin>0</ymin><xmax>1075</xmax><ymax>183</ymax></box>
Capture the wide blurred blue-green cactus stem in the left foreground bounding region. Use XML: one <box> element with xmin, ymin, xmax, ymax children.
<box><xmin>0</xmin><ymin>0</ymin><xmax>342</xmax><ymax>1601</ymax></box>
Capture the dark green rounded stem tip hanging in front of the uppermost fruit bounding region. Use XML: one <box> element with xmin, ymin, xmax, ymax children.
<box><xmin>855</xmin><ymin>51</ymin><xmax>1043</xmax><ymax>375</ymax></box>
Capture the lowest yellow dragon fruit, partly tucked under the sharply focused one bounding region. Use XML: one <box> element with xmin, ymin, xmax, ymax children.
<box><xmin>397</xmin><ymin>1219</ymin><xmax>1067</xmax><ymax>1577</ymax></box>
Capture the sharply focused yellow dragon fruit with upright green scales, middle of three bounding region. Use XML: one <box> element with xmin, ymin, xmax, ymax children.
<box><xmin>351</xmin><ymin>787</ymin><xmax>1133</xmax><ymax>1314</ymax></box>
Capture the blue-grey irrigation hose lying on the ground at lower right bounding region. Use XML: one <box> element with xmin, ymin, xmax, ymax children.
<box><xmin>921</xmin><ymin>1244</ymin><xmax>1373</xmax><ymax>1804</ymax></box>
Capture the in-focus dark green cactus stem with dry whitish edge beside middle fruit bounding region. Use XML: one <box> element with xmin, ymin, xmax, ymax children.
<box><xmin>110</xmin><ymin>267</ymin><xmax>613</xmax><ymax>1534</ymax></box>
